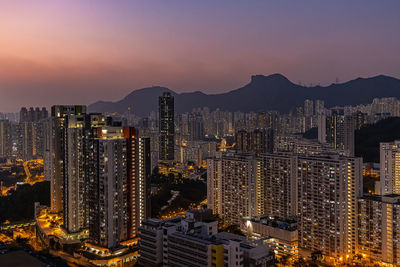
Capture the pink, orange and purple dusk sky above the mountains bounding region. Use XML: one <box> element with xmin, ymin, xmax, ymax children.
<box><xmin>0</xmin><ymin>0</ymin><xmax>400</xmax><ymax>112</ymax></box>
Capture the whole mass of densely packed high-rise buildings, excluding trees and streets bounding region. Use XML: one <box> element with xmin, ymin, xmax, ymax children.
<box><xmin>0</xmin><ymin>93</ymin><xmax>400</xmax><ymax>266</ymax></box>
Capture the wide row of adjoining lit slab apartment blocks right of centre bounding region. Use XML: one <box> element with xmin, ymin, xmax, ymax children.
<box><xmin>207</xmin><ymin>150</ymin><xmax>362</xmax><ymax>257</ymax></box>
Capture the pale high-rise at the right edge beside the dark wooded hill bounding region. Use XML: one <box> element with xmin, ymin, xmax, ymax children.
<box><xmin>380</xmin><ymin>141</ymin><xmax>400</xmax><ymax>195</ymax></box>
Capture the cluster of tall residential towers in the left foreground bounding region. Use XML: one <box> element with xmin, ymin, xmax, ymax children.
<box><xmin>45</xmin><ymin>106</ymin><xmax>151</xmax><ymax>252</ymax></box>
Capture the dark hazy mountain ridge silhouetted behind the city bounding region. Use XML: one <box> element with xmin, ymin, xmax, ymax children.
<box><xmin>89</xmin><ymin>74</ymin><xmax>400</xmax><ymax>116</ymax></box>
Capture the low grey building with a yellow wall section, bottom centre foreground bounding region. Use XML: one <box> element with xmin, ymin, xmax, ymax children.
<box><xmin>139</xmin><ymin>210</ymin><xmax>274</xmax><ymax>267</ymax></box>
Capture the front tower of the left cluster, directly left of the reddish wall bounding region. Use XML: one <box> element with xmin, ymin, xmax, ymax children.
<box><xmin>89</xmin><ymin>138</ymin><xmax>128</xmax><ymax>248</ymax></box>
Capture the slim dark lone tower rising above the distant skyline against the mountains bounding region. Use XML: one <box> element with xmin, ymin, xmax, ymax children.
<box><xmin>158</xmin><ymin>93</ymin><xmax>175</xmax><ymax>161</ymax></box>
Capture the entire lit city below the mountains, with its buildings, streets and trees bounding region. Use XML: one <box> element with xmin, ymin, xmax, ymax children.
<box><xmin>0</xmin><ymin>96</ymin><xmax>400</xmax><ymax>267</ymax></box>
